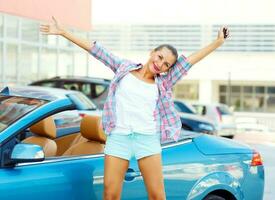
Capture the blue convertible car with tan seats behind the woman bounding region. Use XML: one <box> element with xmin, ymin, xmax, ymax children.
<box><xmin>0</xmin><ymin>88</ymin><xmax>264</xmax><ymax>200</ymax></box>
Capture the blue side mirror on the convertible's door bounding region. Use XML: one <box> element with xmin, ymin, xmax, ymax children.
<box><xmin>11</xmin><ymin>143</ymin><xmax>45</xmax><ymax>163</ymax></box>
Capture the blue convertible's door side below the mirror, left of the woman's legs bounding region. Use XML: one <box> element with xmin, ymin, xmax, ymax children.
<box><xmin>0</xmin><ymin>154</ymin><xmax>104</xmax><ymax>200</ymax></box>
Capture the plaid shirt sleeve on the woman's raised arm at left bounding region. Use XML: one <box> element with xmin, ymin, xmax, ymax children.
<box><xmin>90</xmin><ymin>42</ymin><xmax>123</xmax><ymax>73</ymax></box>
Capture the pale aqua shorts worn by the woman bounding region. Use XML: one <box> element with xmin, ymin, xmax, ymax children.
<box><xmin>104</xmin><ymin>133</ymin><xmax>161</xmax><ymax>160</ymax></box>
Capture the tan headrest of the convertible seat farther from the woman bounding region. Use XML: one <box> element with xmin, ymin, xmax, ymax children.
<box><xmin>30</xmin><ymin>116</ymin><xmax>56</xmax><ymax>139</ymax></box>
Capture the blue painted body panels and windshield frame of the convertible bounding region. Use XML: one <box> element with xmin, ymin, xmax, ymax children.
<box><xmin>0</xmin><ymin>90</ymin><xmax>264</xmax><ymax>200</ymax></box>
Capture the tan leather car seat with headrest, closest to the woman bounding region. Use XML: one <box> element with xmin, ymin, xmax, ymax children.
<box><xmin>63</xmin><ymin>115</ymin><xmax>106</xmax><ymax>156</ymax></box>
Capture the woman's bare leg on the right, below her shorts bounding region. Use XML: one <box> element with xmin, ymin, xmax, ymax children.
<box><xmin>138</xmin><ymin>154</ymin><xmax>166</xmax><ymax>200</ymax></box>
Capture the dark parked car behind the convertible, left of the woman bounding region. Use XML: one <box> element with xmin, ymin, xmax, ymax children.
<box><xmin>29</xmin><ymin>76</ymin><xmax>110</xmax><ymax>109</ymax></box>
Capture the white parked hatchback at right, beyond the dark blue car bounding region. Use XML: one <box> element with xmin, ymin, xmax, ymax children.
<box><xmin>192</xmin><ymin>103</ymin><xmax>236</xmax><ymax>138</ymax></box>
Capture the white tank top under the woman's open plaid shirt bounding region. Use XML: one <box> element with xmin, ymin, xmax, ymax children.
<box><xmin>112</xmin><ymin>73</ymin><xmax>158</xmax><ymax>135</ymax></box>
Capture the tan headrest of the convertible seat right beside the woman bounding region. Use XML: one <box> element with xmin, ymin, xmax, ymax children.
<box><xmin>80</xmin><ymin>115</ymin><xmax>106</xmax><ymax>143</ymax></box>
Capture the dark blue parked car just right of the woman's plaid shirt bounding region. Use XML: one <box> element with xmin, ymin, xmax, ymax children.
<box><xmin>174</xmin><ymin>100</ymin><xmax>217</xmax><ymax>135</ymax></box>
